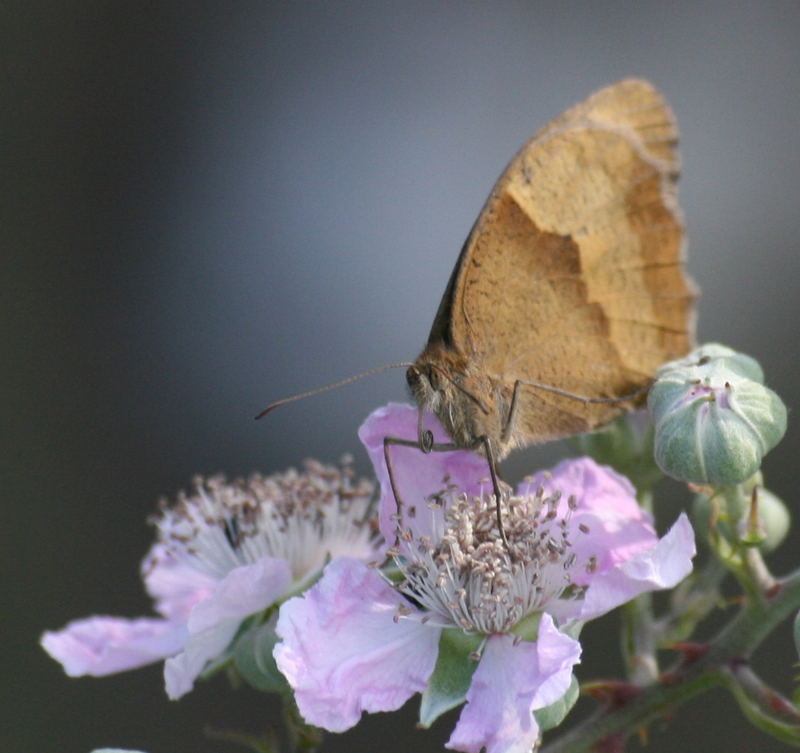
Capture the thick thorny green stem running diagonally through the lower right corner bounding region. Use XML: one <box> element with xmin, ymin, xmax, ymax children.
<box><xmin>541</xmin><ymin>570</ymin><xmax>800</xmax><ymax>753</ymax></box>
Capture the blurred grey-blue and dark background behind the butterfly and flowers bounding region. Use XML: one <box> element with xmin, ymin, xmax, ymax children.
<box><xmin>6</xmin><ymin>0</ymin><xmax>800</xmax><ymax>753</ymax></box>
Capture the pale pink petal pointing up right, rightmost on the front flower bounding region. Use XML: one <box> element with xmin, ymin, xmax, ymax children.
<box><xmin>576</xmin><ymin>513</ymin><xmax>696</xmax><ymax>621</ymax></box>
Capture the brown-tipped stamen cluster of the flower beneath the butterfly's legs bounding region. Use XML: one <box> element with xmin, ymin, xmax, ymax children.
<box><xmin>392</xmin><ymin>478</ymin><xmax>591</xmax><ymax>634</ymax></box>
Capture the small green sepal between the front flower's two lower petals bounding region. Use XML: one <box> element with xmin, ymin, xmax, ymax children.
<box><xmin>419</xmin><ymin>629</ymin><xmax>483</xmax><ymax>727</ymax></box>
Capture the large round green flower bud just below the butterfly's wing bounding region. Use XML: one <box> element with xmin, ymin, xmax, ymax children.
<box><xmin>647</xmin><ymin>344</ymin><xmax>786</xmax><ymax>485</ymax></box>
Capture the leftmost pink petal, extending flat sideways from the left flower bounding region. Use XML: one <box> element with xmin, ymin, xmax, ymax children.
<box><xmin>41</xmin><ymin>617</ymin><xmax>188</xmax><ymax>677</ymax></box>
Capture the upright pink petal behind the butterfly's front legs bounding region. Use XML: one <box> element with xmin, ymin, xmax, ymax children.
<box><xmin>358</xmin><ymin>403</ymin><xmax>489</xmax><ymax>545</ymax></box>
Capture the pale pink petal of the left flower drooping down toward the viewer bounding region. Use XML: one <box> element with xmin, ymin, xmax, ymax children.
<box><xmin>164</xmin><ymin>557</ymin><xmax>291</xmax><ymax>700</ymax></box>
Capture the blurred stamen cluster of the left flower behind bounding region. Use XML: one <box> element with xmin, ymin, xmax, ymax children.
<box><xmin>145</xmin><ymin>458</ymin><xmax>374</xmax><ymax>578</ymax></box>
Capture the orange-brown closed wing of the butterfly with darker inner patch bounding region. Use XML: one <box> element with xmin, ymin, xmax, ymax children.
<box><xmin>429</xmin><ymin>79</ymin><xmax>696</xmax><ymax>444</ymax></box>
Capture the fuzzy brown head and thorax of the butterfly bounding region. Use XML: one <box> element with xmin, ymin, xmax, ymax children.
<box><xmin>406</xmin><ymin>343</ymin><xmax>507</xmax><ymax>457</ymax></box>
